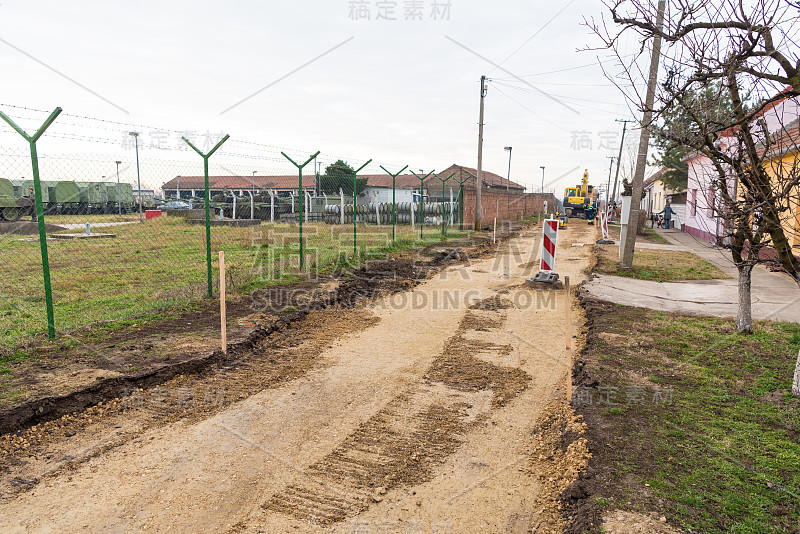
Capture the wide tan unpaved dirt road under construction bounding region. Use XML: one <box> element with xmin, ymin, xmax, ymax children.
<box><xmin>0</xmin><ymin>221</ymin><xmax>594</xmax><ymax>533</ymax></box>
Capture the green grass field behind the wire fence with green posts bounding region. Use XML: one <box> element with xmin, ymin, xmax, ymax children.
<box><xmin>0</xmin><ymin>216</ymin><xmax>463</xmax><ymax>351</ymax></box>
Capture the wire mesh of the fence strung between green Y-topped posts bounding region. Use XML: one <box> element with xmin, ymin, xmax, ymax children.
<box><xmin>0</xmin><ymin>105</ymin><xmax>556</xmax><ymax>351</ymax></box>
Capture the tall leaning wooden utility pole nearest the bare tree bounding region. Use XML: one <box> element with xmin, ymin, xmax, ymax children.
<box><xmin>620</xmin><ymin>0</ymin><xmax>666</xmax><ymax>269</ymax></box>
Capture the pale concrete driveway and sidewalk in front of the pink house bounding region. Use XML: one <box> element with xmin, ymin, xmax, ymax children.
<box><xmin>583</xmin><ymin>226</ymin><xmax>800</xmax><ymax>323</ymax></box>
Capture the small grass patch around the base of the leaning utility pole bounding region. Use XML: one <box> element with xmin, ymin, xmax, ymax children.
<box><xmin>595</xmin><ymin>246</ymin><xmax>728</xmax><ymax>282</ymax></box>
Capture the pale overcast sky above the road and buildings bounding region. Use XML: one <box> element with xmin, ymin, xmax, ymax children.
<box><xmin>0</xmin><ymin>0</ymin><xmax>656</xmax><ymax>196</ymax></box>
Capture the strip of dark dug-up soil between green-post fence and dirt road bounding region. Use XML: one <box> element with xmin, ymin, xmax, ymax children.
<box><xmin>0</xmin><ymin>229</ymin><xmax>506</xmax><ymax>434</ymax></box>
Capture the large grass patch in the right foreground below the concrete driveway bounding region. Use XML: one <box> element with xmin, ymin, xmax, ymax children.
<box><xmin>580</xmin><ymin>305</ymin><xmax>800</xmax><ymax>533</ymax></box>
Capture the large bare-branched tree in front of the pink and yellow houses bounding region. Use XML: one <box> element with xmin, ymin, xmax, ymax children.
<box><xmin>587</xmin><ymin>0</ymin><xmax>800</xmax><ymax>340</ymax></box>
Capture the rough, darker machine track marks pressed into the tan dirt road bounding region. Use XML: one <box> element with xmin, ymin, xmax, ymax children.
<box><xmin>264</xmin><ymin>302</ymin><xmax>530</xmax><ymax>525</ymax></box>
